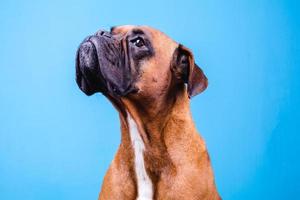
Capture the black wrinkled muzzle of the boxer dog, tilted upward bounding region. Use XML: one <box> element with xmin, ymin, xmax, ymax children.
<box><xmin>76</xmin><ymin>31</ymin><xmax>137</xmax><ymax>97</ymax></box>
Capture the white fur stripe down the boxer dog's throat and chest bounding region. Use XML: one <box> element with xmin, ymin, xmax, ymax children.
<box><xmin>127</xmin><ymin>113</ymin><xmax>153</xmax><ymax>200</ymax></box>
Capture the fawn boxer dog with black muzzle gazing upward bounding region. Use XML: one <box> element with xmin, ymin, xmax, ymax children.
<box><xmin>76</xmin><ymin>25</ymin><xmax>221</xmax><ymax>200</ymax></box>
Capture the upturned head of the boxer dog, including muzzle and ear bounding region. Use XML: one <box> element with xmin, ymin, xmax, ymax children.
<box><xmin>76</xmin><ymin>25</ymin><xmax>207</xmax><ymax>104</ymax></box>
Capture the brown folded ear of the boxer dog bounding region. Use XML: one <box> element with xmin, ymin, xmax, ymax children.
<box><xmin>172</xmin><ymin>44</ymin><xmax>208</xmax><ymax>98</ymax></box>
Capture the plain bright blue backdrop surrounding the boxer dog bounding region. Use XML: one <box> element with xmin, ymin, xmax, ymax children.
<box><xmin>0</xmin><ymin>0</ymin><xmax>300</xmax><ymax>200</ymax></box>
